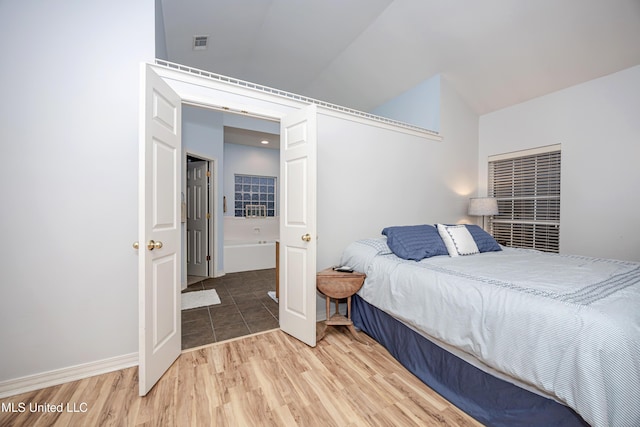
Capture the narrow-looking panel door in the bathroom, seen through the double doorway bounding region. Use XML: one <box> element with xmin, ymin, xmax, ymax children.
<box><xmin>187</xmin><ymin>160</ymin><xmax>209</xmax><ymax>276</ymax></box>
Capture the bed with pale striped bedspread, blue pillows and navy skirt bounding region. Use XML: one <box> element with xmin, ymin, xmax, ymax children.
<box><xmin>341</xmin><ymin>225</ymin><xmax>640</xmax><ymax>427</ymax></box>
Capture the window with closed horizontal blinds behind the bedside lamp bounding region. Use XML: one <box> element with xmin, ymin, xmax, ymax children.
<box><xmin>489</xmin><ymin>145</ymin><xmax>561</xmax><ymax>253</ymax></box>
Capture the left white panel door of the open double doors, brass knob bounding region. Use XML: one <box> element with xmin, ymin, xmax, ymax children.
<box><xmin>138</xmin><ymin>64</ymin><xmax>182</xmax><ymax>396</ymax></box>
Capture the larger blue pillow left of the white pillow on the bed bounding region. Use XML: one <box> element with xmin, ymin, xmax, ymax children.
<box><xmin>382</xmin><ymin>224</ymin><xmax>449</xmax><ymax>261</ymax></box>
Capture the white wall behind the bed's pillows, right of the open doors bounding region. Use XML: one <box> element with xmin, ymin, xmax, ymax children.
<box><xmin>317</xmin><ymin>75</ymin><xmax>478</xmax><ymax>270</ymax></box>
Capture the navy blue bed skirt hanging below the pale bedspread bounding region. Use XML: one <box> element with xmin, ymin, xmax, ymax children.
<box><xmin>352</xmin><ymin>294</ymin><xmax>588</xmax><ymax>427</ymax></box>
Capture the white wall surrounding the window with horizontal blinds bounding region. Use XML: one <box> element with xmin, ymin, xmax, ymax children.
<box><xmin>479</xmin><ymin>66</ymin><xmax>640</xmax><ymax>261</ymax></box>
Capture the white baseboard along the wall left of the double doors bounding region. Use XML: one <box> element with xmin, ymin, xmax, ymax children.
<box><xmin>0</xmin><ymin>353</ymin><xmax>138</xmax><ymax>399</ymax></box>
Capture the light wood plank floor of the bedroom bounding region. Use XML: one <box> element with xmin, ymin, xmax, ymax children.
<box><xmin>0</xmin><ymin>328</ymin><xmax>480</xmax><ymax>427</ymax></box>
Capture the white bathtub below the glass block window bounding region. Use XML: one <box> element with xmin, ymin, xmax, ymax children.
<box><xmin>224</xmin><ymin>240</ymin><xmax>276</xmax><ymax>273</ymax></box>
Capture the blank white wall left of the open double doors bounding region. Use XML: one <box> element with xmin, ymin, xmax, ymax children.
<box><xmin>0</xmin><ymin>0</ymin><xmax>154</xmax><ymax>381</ymax></box>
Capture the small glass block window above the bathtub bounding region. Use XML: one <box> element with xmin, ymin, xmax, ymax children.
<box><xmin>234</xmin><ymin>174</ymin><xmax>278</xmax><ymax>217</ymax></box>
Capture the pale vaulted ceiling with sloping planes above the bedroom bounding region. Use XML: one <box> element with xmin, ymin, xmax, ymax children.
<box><xmin>161</xmin><ymin>0</ymin><xmax>640</xmax><ymax>114</ymax></box>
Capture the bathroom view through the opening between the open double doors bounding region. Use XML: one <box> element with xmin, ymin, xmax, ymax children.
<box><xmin>181</xmin><ymin>115</ymin><xmax>280</xmax><ymax>350</ymax></box>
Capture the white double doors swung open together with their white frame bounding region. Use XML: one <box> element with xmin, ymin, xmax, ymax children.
<box><xmin>138</xmin><ymin>64</ymin><xmax>317</xmax><ymax>395</ymax></box>
